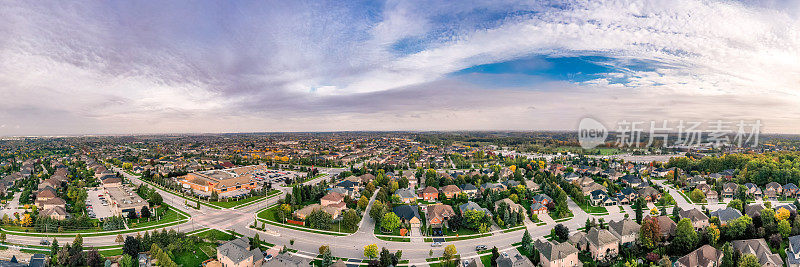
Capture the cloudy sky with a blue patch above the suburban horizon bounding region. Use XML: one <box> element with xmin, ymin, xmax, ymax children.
<box><xmin>0</xmin><ymin>0</ymin><xmax>800</xmax><ymax>136</ymax></box>
